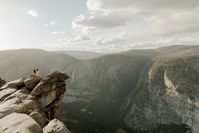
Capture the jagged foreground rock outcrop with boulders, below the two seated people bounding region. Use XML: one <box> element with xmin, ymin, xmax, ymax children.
<box><xmin>0</xmin><ymin>72</ymin><xmax>70</xmax><ymax>133</ymax></box>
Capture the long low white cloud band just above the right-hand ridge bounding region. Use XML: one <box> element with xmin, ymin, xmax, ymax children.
<box><xmin>93</xmin><ymin>29</ymin><xmax>199</xmax><ymax>50</ymax></box>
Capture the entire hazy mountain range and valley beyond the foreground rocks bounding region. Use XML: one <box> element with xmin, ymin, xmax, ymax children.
<box><xmin>0</xmin><ymin>46</ymin><xmax>199</xmax><ymax>133</ymax></box>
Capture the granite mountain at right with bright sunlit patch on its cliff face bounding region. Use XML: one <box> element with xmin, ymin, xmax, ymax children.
<box><xmin>124</xmin><ymin>54</ymin><xmax>199</xmax><ymax>133</ymax></box>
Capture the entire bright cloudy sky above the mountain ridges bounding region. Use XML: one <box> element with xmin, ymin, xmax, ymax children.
<box><xmin>0</xmin><ymin>0</ymin><xmax>199</xmax><ymax>52</ymax></box>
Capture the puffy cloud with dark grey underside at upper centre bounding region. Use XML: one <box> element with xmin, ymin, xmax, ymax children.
<box><xmin>72</xmin><ymin>12</ymin><xmax>131</xmax><ymax>33</ymax></box>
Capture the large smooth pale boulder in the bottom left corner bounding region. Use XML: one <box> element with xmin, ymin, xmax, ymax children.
<box><xmin>0</xmin><ymin>113</ymin><xmax>42</xmax><ymax>133</ymax></box>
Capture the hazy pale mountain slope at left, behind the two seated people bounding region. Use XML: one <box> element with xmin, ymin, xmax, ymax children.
<box><xmin>0</xmin><ymin>49</ymin><xmax>78</xmax><ymax>81</ymax></box>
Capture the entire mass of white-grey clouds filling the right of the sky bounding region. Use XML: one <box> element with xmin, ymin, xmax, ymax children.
<box><xmin>68</xmin><ymin>0</ymin><xmax>199</xmax><ymax>49</ymax></box>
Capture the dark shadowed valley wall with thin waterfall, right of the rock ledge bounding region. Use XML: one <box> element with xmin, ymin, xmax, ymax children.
<box><xmin>63</xmin><ymin>55</ymin><xmax>154</xmax><ymax>133</ymax></box>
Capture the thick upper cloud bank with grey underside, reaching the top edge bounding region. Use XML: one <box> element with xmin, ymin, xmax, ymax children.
<box><xmin>72</xmin><ymin>0</ymin><xmax>199</xmax><ymax>35</ymax></box>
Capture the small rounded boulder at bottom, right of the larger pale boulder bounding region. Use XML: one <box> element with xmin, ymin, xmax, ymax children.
<box><xmin>43</xmin><ymin>119</ymin><xmax>71</xmax><ymax>133</ymax></box>
